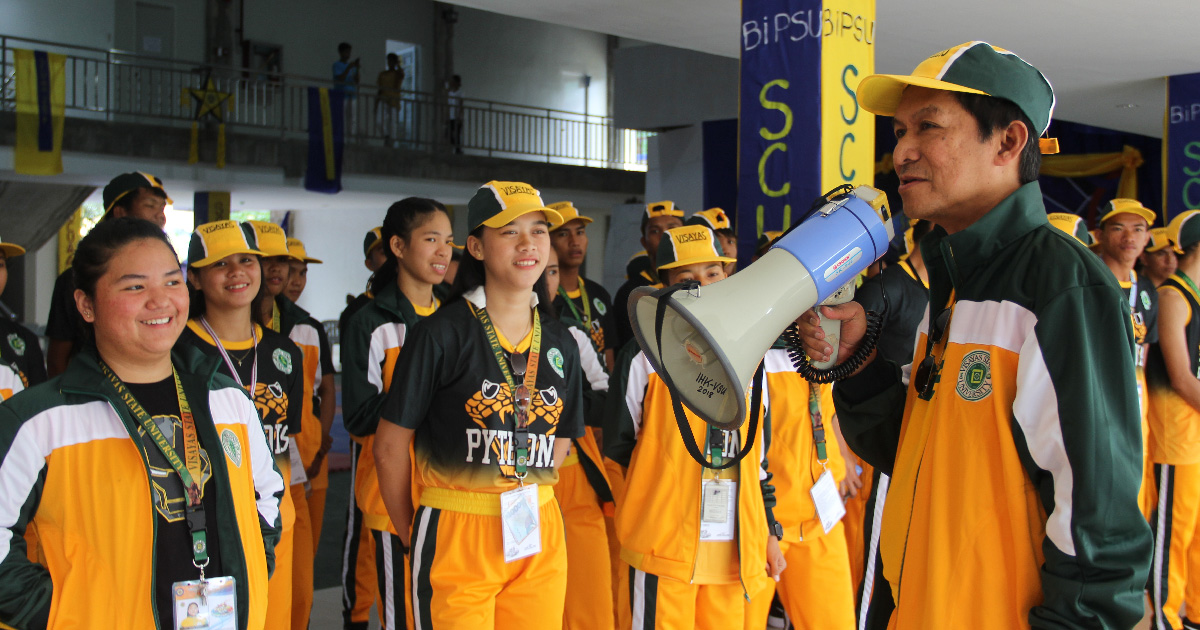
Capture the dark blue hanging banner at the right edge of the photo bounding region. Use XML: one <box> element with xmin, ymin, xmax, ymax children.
<box><xmin>1163</xmin><ymin>73</ymin><xmax>1200</xmax><ymax>224</ymax></box>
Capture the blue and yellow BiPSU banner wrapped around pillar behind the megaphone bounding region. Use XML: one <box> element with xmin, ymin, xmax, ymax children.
<box><xmin>737</xmin><ymin>0</ymin><xmax>875</xmax><ymax>260</ymax></box>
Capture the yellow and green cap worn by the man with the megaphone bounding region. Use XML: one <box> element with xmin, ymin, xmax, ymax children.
<box><xmin>857</xmin><ymin>42</ymin><xmax>1055</xmax><ymax>136</ymax></box>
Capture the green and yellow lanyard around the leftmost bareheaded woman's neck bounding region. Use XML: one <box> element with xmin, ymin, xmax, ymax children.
<box><xmin>100</xmin><ymin>361</ymin><xmax>209</xmax><ymax>566</ymax></box>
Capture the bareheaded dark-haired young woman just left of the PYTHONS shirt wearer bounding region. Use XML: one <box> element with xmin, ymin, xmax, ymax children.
<box><xmin>341</xmin><ymin>197</ymin><xmax>454</xmax><ymax>630</ymax></box>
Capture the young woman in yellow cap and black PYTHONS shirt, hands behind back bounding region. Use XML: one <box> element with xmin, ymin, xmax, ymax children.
<box><xmin>374</xmin><ymin>181</ymin><xmax>583</xmax><ymax>630</ymax></box>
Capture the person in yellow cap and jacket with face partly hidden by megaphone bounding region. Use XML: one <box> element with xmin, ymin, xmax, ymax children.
<box><xmin>605</xmin><ymin>226</ymin><xmax>786</xmax><ymax>630</ymax></box>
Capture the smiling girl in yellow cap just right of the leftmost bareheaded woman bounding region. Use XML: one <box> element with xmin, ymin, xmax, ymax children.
<box><xmin>179</xmin><ymin>221</ymin><xmax>304</xmax><ymax>630</ymax></box>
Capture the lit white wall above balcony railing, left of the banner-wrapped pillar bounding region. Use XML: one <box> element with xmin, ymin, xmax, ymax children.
<box><xmin>454</xmin><ymin>6</ymin><xmax>608</xmax><ymax>115</ymax></box>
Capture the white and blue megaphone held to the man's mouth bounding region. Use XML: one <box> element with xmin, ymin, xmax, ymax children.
<box><xmin>629</xmin><ymin>186</ymin><xmax>895</xmax><ymax>430</ymax></box>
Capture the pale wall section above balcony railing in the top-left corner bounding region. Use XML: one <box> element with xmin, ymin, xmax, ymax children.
<box><xmin>0</xmin><ymin>0</ymin><xmax>115</xmax><ymax>50</ymax></box>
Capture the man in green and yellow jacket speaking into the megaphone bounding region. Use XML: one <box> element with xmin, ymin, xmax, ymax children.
<box><xmin>798</xmin><ymin>42</ymin><xmax>1151</xmax><ymax>630</ymax></box>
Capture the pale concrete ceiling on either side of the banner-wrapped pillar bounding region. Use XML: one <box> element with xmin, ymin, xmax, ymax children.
<box><xmin>451</xmin><ymin>0</ymin><xmax>1200</xmax><ymax>137</ymax></box>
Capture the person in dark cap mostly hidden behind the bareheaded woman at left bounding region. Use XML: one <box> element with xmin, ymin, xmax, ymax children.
<box><xmin>46</xmin><ymin>172</ymin><xmax>172</xmax><ymax>377</ymax></box>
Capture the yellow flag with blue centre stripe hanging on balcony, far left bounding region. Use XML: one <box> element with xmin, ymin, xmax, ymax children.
<box><xmin>13</xmin><ymin>49</ymin><xmax>66</xmax><ymax>175</ymax></box>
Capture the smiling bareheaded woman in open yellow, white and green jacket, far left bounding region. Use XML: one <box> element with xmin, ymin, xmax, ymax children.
<box><xmin>0</xmin><ymin>218</ymin><xmax>284</xmax><ymax>629</ymax></box>
